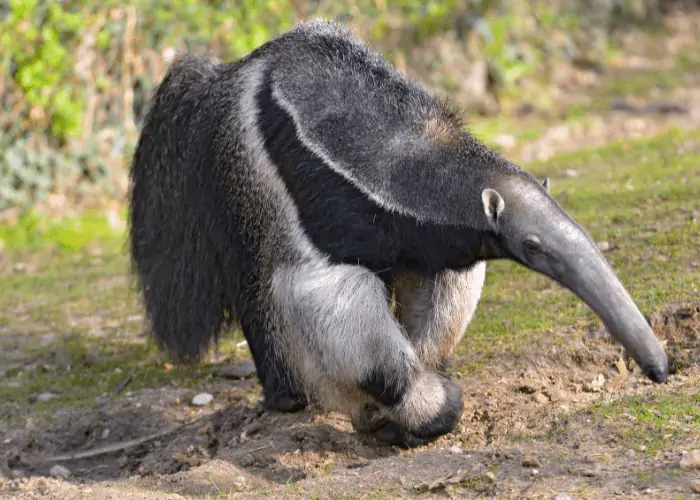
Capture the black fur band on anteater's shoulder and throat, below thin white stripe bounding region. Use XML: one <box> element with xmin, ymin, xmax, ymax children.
<box><xmin>257</xmin><ymin>68</ymin><xmax>484</xmax><ymax>276</ymax></box>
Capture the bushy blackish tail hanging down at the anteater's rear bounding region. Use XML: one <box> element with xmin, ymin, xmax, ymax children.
<box><xmin>129</xmin><ymin>55</ymin><xmax>232</xmax><ymax>362</ymax></box>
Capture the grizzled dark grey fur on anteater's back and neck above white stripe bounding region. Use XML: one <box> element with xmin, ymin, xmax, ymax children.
<box><xmin>252</xmin><ymin>22</ymin><xmax>536</xmax><ymax>230</ymax></box>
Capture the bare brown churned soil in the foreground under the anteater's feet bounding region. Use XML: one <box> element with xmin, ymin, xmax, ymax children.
<box><xmin>0</xmin><ymin>304</ymin><xmax>700</xmax><ymax>498</ymax></box>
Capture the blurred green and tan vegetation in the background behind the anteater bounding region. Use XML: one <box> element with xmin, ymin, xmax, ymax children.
<box><xmin>0</xmin><ymin>0</ymin><xmax>688</xmax><ymax>210</ymax></box>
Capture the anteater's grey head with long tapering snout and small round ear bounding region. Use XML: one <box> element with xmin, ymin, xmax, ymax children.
<box><xmin>480</xmin><ymin>172</ymin><xmax>668</xmax><ymax>382</ymax></box>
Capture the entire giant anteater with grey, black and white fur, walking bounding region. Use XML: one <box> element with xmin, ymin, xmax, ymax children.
<box><xmin>130</xmin><ymin>20</ymin><xmax>667</xmax><ymax>446</ymax></box>
